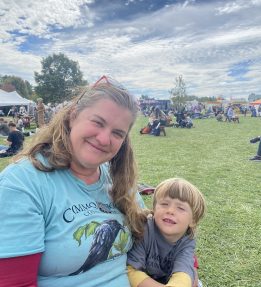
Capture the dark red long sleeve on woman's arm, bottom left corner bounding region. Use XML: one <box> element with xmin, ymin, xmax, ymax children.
<box><xmin>0</xmin><ymin>253</ymin><xmax>42</xmax><ymax>287</ymax></box>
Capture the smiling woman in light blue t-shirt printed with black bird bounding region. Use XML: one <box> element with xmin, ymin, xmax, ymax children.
<box><xmin>0</xmin><ymin>77</ymin><xmax>145</xmax><ymax>287</ymax></box>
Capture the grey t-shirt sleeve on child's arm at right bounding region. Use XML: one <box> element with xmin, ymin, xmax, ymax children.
<box><xmin>172</xmin><ymin>236</ymin><xmax>195</xmax><ymax>281</ymax></box>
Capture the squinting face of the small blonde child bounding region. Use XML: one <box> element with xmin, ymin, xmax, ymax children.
<box><xmin>154</xmin><ymin>197</ymin><xmax>194</xmax><ymax>243</ymax></box>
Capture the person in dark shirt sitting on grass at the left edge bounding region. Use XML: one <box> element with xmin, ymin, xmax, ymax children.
<box><xmin>0</xmin><ymin>122</ymin><xmax>24</xmax><ymax>158</ymax></box>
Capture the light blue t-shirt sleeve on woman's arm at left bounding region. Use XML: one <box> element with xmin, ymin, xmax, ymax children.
<box><xmin>0</xmin><ymin>164</ymin><xmax>44</xmax><ymax>258</ymax></box>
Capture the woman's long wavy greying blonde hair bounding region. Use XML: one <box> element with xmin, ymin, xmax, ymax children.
<box><xmin>15</xmin><ymin>83</ymin><xmax>146</xmax><ymax>238</ymax></box>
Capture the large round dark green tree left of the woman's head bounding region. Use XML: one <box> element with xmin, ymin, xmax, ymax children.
<box><xmin>34</xmin><ymin>53</ymin><xmax>87</xmax><ymax>103</ymax></box>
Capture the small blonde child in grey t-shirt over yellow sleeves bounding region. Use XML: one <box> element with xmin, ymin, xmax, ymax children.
<box><xmin>127</xmin><ymin>178</ymin><xmax>205</xmax><ymax>287</ymax></box>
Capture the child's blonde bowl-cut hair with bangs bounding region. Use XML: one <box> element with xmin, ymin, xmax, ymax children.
<box><xmin>153</xmin><ymin>178</ymin><xmax>206</xmax><ymax>238</ymax></box>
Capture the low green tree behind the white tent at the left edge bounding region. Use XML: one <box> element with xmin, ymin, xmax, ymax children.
<box><xmin>0</xmin><ymin>75</ymin><xmax>33</xmax><ymax>99</ymax></box>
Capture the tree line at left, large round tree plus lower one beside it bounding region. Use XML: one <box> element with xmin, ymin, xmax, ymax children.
<box><xmin>0</xmin><ymin>53</ymin><xmax>88</xmax><ymax>103</ymax></box>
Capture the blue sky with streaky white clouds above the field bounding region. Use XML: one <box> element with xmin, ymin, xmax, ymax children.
<box><xmin>0</xmin><ymin>0</ymin><xmax>261</xmax><ymax>99</ymax></box>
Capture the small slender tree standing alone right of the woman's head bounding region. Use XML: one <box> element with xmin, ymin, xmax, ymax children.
<box><xmin>169</xmin><ymin>75</ymin><xmax>187</xmax><ymax>110</ymax></box>
